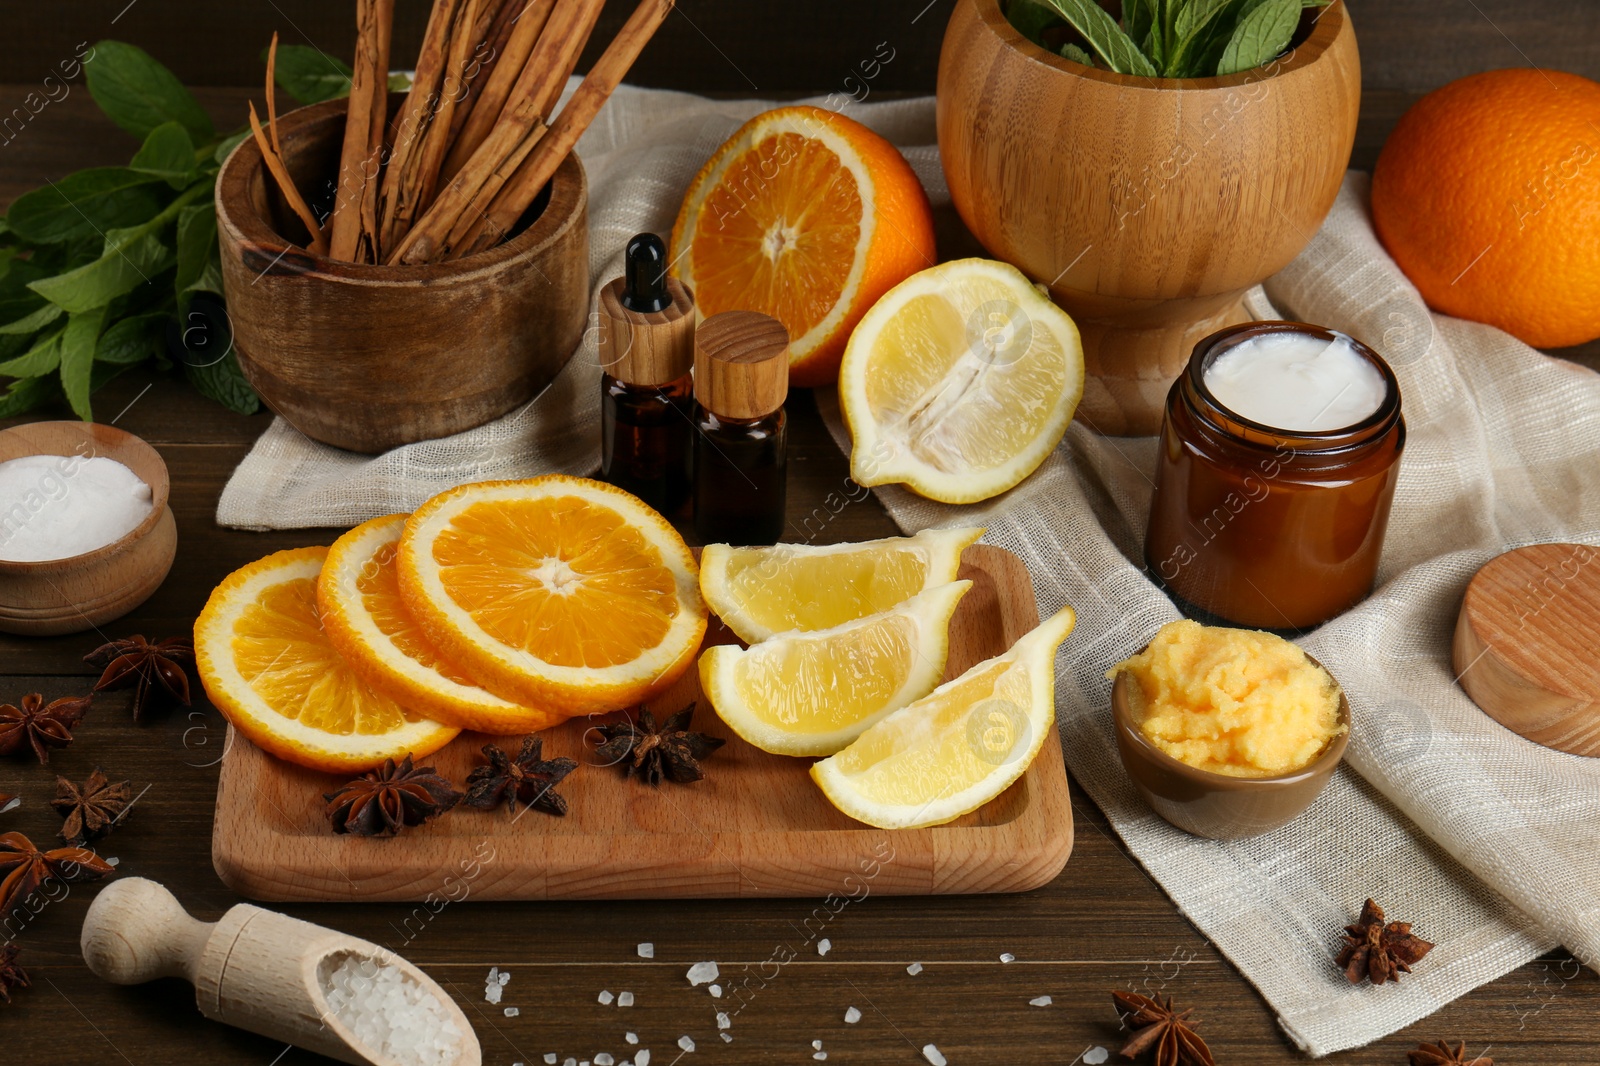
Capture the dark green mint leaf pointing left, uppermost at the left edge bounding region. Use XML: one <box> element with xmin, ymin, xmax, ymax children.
<box><xmin>6</xmin><ymin>166</ymin><xmax>162</xmax><ymax>245</ymax></box>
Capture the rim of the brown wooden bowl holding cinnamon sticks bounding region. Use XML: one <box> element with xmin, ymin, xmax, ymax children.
<box><xmin>216</xmin><ymin>99</ymin><xmax>589</xmax><ymax>287</ymax></box>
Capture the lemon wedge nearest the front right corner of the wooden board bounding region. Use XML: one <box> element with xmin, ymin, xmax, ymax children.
<box><xmin>811</xmin><ymin>607</ymin><xmax>1077</xmax><ymax>829</ymax></box>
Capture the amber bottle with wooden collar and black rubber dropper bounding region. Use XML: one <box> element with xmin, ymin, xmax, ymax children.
<box><xmin>598</xmin><ymin>234</ymin><xmax>694</xmax><ymax>514</ymax></box>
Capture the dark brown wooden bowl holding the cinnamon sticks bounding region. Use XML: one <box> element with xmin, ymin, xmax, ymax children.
<box><xmin>216</xmin><ymin>94</ymin><xmax>589</xmax><ymax>453</ymax></box>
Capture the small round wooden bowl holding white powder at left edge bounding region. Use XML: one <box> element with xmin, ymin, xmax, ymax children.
<box><xmin>0</xmin><ymin>423</ymin><xmax>178</xmax><ymax>637</ymax></box>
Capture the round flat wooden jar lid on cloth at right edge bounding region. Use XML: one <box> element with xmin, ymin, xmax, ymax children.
<box><xmin>1453</xmin><ymin>544</ymin><xmax>1600</xmax><ymax>757</ymax></box>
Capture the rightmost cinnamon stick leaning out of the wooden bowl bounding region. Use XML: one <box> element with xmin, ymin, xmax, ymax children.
<box><xmin>450</xmin><ymin>0</ymin><xmax>674</xmax><ymax>258</ymax></box>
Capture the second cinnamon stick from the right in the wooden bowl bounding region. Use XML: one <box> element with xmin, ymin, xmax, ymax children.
<box><xmin>387</xmin><ymin>0</ymin><xmax>605</xmax><ymax>264</ymax></box>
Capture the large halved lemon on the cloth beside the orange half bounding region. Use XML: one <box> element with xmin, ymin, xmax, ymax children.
<box><xmin>838</xmin><ymin>259</ymin><xmax>1083</xmax><ymax>503</ymax></box>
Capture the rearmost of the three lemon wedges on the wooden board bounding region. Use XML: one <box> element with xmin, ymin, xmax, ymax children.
<box><xmin>701</xmin><ymin>527</ymin><xmax>984</xmax><ymax>643</ymax></box>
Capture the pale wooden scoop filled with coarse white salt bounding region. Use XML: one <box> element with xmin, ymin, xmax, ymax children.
<box><xmin>80</xmin><ymin>877</ymin><xmax>483</xmax><ymax>1066</ymax></box>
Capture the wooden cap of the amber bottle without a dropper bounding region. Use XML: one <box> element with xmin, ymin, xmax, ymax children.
<box><xmin>694</xmin><ymin>311</ymin><xmax>789</xmax><ymax>418</ymax></box>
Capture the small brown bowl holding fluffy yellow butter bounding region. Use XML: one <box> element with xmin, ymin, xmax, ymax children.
<box><xmin>1110</xmin><ymin>656</ymin><xmax>1350</xmax><ymax>840</ymax></box>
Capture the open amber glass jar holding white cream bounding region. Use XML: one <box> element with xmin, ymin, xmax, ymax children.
<box><xmin>1144</xmin><ymin>322</ymin><xmax>1405</xmax><ymax>629</ymax></box>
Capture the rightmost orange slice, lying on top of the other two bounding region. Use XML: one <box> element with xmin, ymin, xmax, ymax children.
<box><xmin>398</xmin><ymin>474</ymin><xmax>706</xmax><ymax>717</ymax></box>
